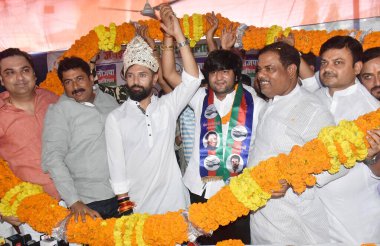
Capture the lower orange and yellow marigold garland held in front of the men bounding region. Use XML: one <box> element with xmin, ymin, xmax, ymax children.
<box><xmin>0</xmin><ymin>109</ymin><xmax>380</xmax><ymax>245</ymax></box>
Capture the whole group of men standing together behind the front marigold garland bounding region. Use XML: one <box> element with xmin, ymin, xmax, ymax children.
<box><xmin>0</xmin><ymin>5</ymin><xmax>380</xmax><ymax>244</ymax></box>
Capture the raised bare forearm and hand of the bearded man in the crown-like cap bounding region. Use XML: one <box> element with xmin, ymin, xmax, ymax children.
<box><xmin>160</xmin><ymin>5</ymin><xmax>199</xmax><ymax>78</ymax></box>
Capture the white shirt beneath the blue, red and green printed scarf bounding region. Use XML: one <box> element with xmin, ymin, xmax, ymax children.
<box><xmin>183</xmin><ymin>85</ymin><xmax>265</xmax><ymax>199</ymax></box>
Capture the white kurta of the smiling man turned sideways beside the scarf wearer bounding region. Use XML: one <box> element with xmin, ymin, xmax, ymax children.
<box><xmin>249</xmin><ymin>85</ymin><xmax>334</xmax><ymax>244</ymax></box>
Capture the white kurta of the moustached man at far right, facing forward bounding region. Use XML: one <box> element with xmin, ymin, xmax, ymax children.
<box><xmin>317</xmin><ymin>81</ymin><xmax>380</xmax><ymax>245</ymax></box>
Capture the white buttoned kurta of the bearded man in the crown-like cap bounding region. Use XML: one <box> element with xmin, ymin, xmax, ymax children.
<box><xmin>106</xmin><ymin>72</ymin><xmax>203</xmax><ymax>214</ymax></box>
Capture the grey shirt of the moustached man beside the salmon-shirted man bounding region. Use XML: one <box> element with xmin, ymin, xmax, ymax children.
<box><xmin>42</xmin><ymin>88</ymin><xmax>118</xmax><ymax>206</ymax></box>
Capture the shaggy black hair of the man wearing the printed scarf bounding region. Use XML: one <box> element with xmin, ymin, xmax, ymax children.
<box><xmin>203</xmin><ymin>50</ymin><xmax>243</xmax><ymax>80</ymax></box>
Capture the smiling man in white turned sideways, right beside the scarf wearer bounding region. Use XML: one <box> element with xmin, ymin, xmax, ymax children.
<box><xmin>249</xmin><ymin>42</ymin><xmax>334</xmax><ymax>244</ymax></box>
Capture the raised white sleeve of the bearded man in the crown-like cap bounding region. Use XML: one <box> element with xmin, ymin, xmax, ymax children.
<box><xmin>166</xmin><ymin>67</ymin><xmax>203</xmax><ymax>118</ymax></box>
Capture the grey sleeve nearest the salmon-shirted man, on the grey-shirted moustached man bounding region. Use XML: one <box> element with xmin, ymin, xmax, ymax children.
<box><xmin>42</xmin><ymin>106</ymin><xmax>80</xmax><ymax>207</ymax></box>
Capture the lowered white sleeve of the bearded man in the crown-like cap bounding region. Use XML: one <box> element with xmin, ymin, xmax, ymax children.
<box><xmin>105</xmin><ymin>114</ymin><xmax>130</xmax><ymax>195</ymax></box>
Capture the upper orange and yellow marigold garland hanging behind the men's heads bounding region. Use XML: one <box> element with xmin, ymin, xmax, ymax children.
<box><xmin>40</xmin><ymin>13</ymin><xmax>380</xmax><ymax>95</ymax></box>
